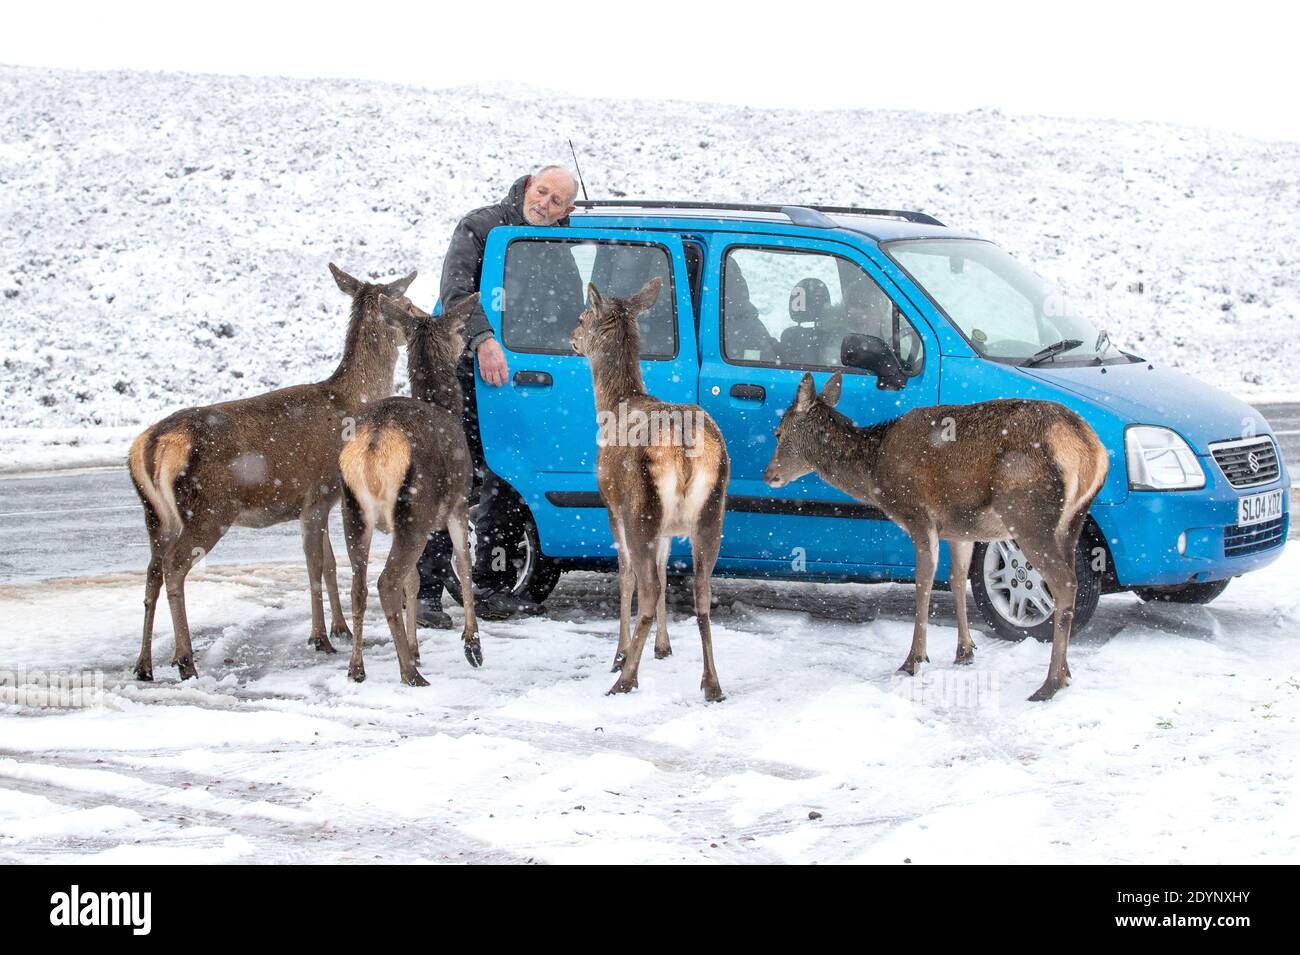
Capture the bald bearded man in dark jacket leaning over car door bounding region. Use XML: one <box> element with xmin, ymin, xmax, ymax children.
<box><xmin>416</xmin><ymin>166</ymin><xmax>579</xmax><ymax>629</ymax></box>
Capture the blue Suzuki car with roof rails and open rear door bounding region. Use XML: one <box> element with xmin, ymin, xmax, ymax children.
<box><xmin>452</xmin><ymin>201</ymin><xmax>1290</xmax><ymax>639</ymax></box>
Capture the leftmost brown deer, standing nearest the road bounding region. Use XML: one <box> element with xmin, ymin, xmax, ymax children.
<box><xmin>129</xmin><ymin>264</ymin><xmax>415</xmax><ymax>680</ymax></box>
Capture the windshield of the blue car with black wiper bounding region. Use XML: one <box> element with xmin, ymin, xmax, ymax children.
<box><xmin>885</xmin><ymin>239</ymin><xmax>1119</xmax><ymax>364</ymax></box>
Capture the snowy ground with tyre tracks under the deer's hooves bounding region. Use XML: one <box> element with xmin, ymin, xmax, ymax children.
<box><xmin>0</xmin><ymin>547</ymin><xmax>1300</xmax><ymax>863</ymax></box>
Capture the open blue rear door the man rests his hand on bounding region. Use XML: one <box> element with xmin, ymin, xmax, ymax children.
<box><xmin>475</xmin><ymin>226</ymin><xmax>698</xmax><ymax>561</ymax></box>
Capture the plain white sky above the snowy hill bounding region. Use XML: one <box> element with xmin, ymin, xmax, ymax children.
<box><xmin>0</xmin><ymin>0</ymin><xmax>1300</xmax><ymax>140</ymax></box>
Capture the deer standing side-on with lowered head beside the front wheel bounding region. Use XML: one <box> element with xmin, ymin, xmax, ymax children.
<box><xmin>763</xmin><ymin>372</ymin><xmax>1109</xmax><ymax>700</ymax></box>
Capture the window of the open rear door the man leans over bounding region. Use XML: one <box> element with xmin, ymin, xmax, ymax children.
<box><xmin>502</xmin><ymin>239</ymin><xmax>677</xmax><ymax>359</ymax></box>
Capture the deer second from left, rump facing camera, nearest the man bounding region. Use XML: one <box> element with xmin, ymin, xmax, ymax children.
<box><xmin>338</xmin><ymin>292</ymin><xmax>484</xmax><ymax>686</ymax></box>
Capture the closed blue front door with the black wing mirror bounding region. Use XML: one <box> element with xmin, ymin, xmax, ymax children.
<box><xmin>699</xmin><ymin>235</ymin><xmax>940</xmax><ymax>577</ymax></box>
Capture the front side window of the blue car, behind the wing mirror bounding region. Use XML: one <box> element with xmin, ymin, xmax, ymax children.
<box><xmin>723</xmin><ymin>248</ymin><xmax>923</xmax><ymax>372</ymax></box>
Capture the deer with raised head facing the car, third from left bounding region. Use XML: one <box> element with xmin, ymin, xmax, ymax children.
<box><xmin>569</xmin><ymin>278</ymin><xmax>731</xmax><ymax>702</ymax></box>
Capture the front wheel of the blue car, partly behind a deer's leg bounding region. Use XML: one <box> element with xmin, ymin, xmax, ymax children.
<box><xmin>970</xmin><ymin>537</ymin><xmax>1101</xmax><ymax>642</ymax></box>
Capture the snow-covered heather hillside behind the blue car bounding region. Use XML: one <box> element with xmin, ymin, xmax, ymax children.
<box><xmin>0</xmin><ymin>68</ymin><xmax>1300</xmax><ymax>439</ymax></box>
